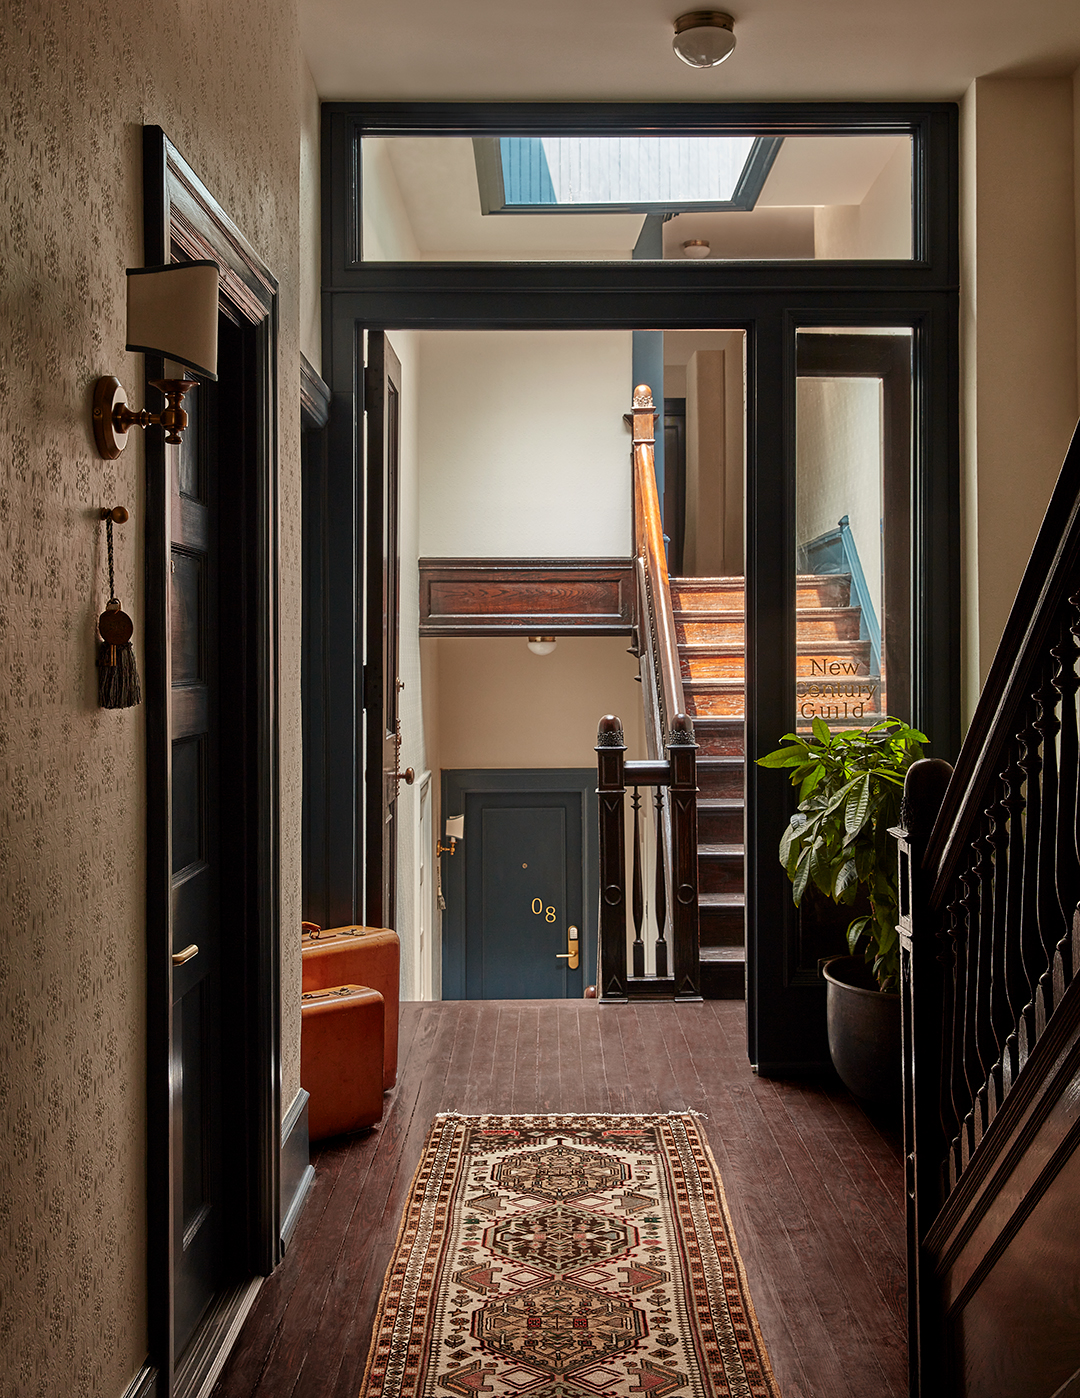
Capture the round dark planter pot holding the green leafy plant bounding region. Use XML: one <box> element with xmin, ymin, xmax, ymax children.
<box><xmin>822</xmin><ymin>956</ymin><xmax>903</xmax><ymax>1106</ymax></box>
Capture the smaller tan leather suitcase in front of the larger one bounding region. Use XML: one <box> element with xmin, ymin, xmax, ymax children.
<box><xmin>300</xmin><ymin>986</ymin><xmax>384</xmax><ymax>1141</ymax></box>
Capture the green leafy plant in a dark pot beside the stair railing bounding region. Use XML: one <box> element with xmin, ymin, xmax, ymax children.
<box><xmin>757</xmin><ymin>717</ymin><xmax>929</xmax><ymax>1099</ymax></box>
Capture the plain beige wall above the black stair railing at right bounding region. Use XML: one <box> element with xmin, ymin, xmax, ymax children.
<box><xmin>961</xmin><ymin>78</ymin><xmax>1077</xmax><ymax>716</ymax></box>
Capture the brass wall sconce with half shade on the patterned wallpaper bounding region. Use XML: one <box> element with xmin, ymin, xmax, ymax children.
<box><xmin>94</xmin><ymin>261</ymin><xmax>218</xmax><ymax>461</ymax></box>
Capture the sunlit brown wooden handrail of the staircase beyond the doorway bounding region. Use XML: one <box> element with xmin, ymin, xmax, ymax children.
<box><xmin>632</xmin><ymin>384</ymin><xmax>686</xmax><ymax>756</ymax></box>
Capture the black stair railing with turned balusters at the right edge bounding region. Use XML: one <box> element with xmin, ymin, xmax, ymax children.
<box><xmin>897</xmin><ymin>416</ymin><xmax>1080</xmax><ymax>1392</ymax></box>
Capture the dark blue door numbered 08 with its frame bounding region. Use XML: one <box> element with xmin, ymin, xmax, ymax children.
<box><xmin>443</xmin><ymin>772</ymin><xmax>595</xmax><ymax>1000</ymax></box>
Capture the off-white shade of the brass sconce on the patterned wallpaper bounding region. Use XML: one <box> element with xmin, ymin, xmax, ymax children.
<box><xmin>127</xmin><ymin>261</ymin><xmax>218</xmax><ymax>379</ymax></box>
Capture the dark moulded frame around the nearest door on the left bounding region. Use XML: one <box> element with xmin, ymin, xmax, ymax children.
<box><xmin>143</xmin><ymin>126</ymin><xmax>281</xmax><ymax>1398</ymax></box>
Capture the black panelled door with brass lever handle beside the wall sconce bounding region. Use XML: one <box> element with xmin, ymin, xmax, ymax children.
<box><xmin>168</xmin><ymin>357</ymin><xmax>231</xmax><ymax>1356</ymax></box>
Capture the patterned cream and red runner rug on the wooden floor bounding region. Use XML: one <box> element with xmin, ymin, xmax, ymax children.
<box><xmin>362</xmin><ymin>1113</ymin><xmax>778</xmax><ymax>1398</ymax></box>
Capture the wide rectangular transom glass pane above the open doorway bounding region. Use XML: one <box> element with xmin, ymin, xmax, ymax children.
<box><xmin>359</xmin><ymin>133</ymin><xmax>912</xmax><ymax>263</ymax></box>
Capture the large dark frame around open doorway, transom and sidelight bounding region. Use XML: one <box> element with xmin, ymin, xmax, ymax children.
<box><xmin>315</xmin><ymin>102</ymin><xmax>960</xmax><ymax>1074</ymax></box>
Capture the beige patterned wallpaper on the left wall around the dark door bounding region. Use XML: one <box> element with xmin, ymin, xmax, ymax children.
<box><xmin>0</xmin><ymin>0</ymin><xmax>300</xmax><ymax>1398</ymax></box>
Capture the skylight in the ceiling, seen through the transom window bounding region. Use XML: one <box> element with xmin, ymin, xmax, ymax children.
<box><xmin>472</xmin><ymin>136</ymin><xmax>781</xmax><ymax>214</ymax></box>
